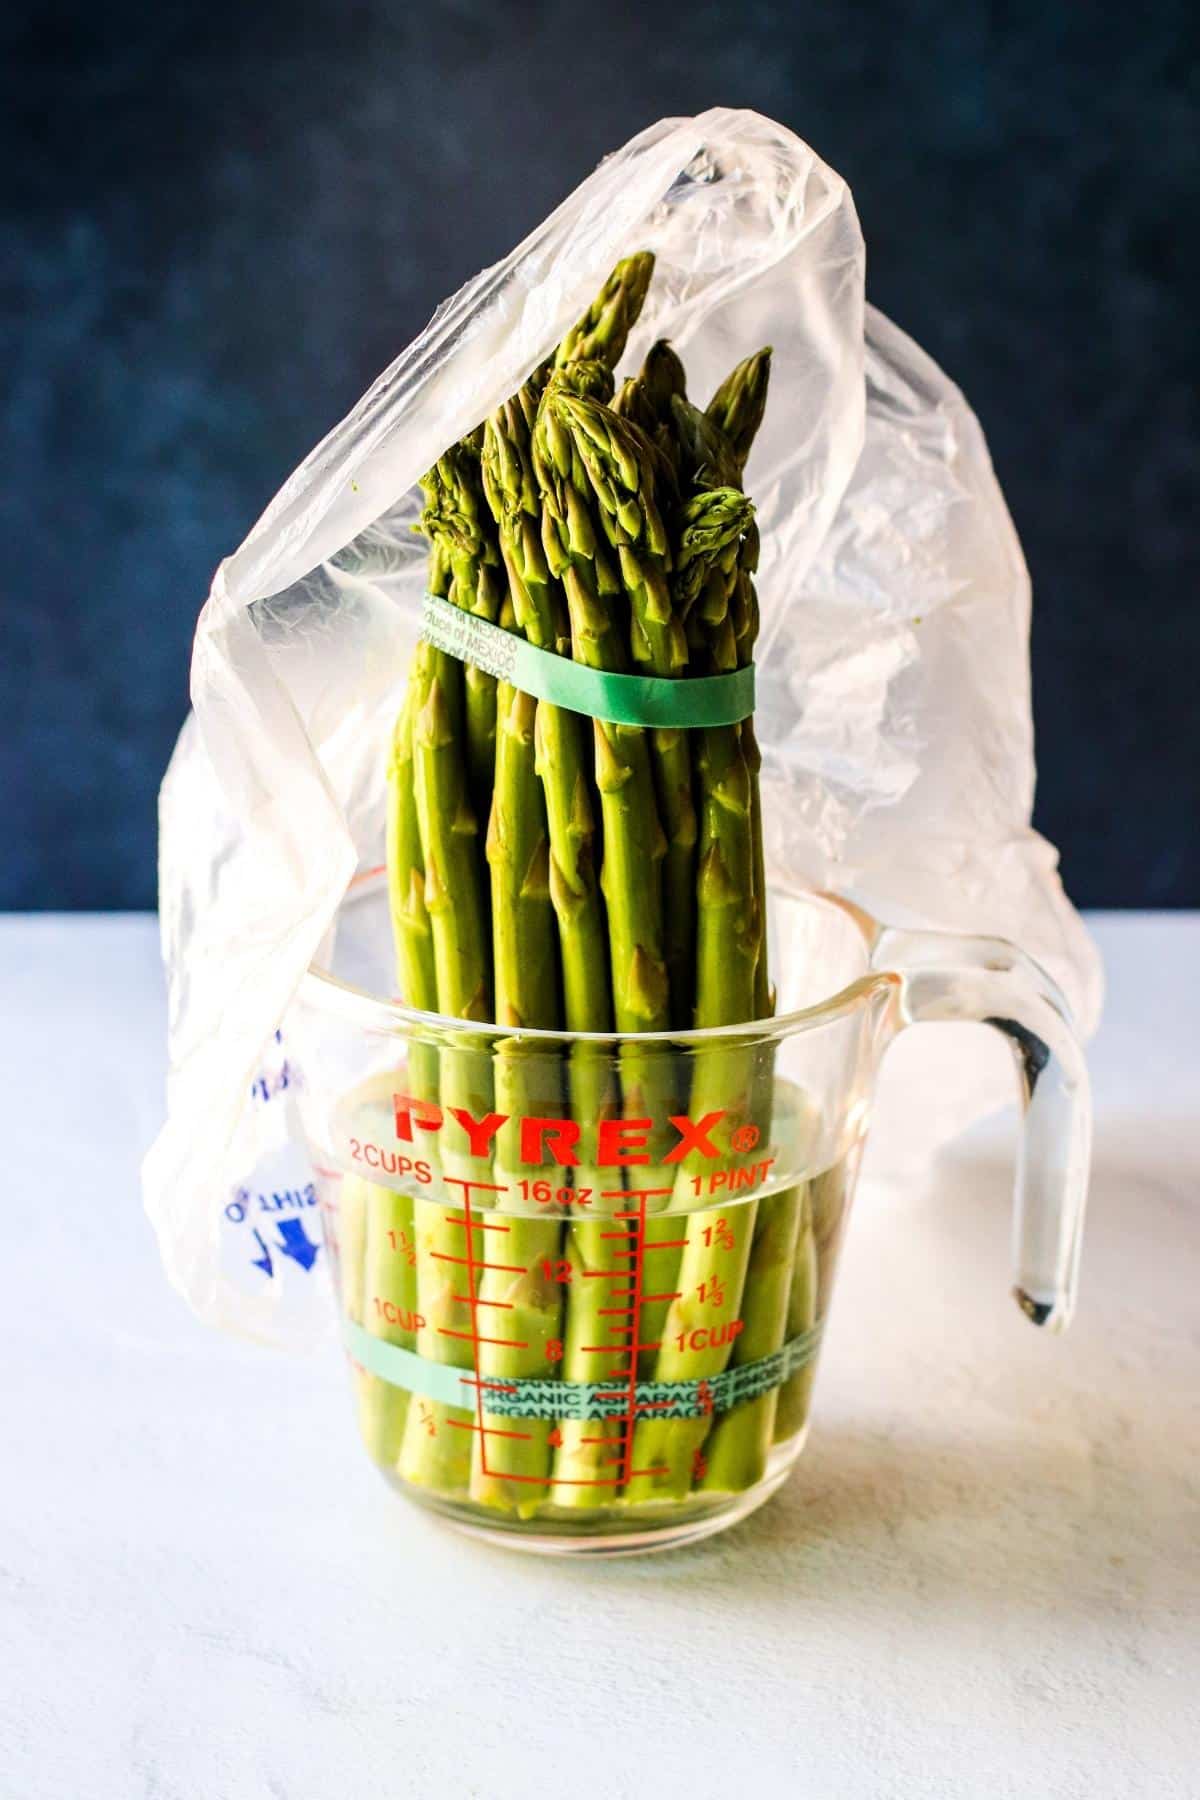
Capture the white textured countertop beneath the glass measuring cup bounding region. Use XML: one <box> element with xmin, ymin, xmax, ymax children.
<box><xmin>0</xmin><ymin>914</ymin><xmax>1200</xmax><ymax>1800</ymax></box>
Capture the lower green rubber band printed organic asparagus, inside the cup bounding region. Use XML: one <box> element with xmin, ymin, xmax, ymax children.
<box><xmin>342</xmin><ymin>1319</ymin><xmax>820</xmax><ymax>1418</ymax></box>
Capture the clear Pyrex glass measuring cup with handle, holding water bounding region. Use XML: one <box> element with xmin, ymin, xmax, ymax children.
<box><xmin>293</xmin><ymin>877</ymin><xmax>1090</xmax><ymax>1553</ymax></box>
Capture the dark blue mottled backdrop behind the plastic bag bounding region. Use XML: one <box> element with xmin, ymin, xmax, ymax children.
<box><xmin>0</xmin><ymin>0</ymin><xmax>1200</xmax><ymax>907</ymax></box>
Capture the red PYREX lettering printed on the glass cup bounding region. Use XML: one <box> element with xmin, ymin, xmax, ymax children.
<box><xmin>392</xmin><ymin>1094</ymin><xmax>725</xmax><ymax>1168</ymax></box>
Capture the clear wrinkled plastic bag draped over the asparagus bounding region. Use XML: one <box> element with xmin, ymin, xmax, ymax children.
<box><xmin>144</xmin><ymin>110</ymin><xmax>1099</xmax><ymax>1343</ymax></box>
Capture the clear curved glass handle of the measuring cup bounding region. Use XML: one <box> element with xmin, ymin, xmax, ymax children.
<box><xmin>873</xmin><ymin>927</ymin><xmax>1092</xmax><ymax>1330</ymax></box>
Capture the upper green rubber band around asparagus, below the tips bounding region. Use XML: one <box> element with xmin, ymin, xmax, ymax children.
<box><xmin>421</xmin><ymin>594</ymin><xmax>754</xmax><ymax>729</ymax></box>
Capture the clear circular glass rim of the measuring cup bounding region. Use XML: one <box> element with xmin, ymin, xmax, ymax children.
<box><xmin>305</xmin><ymin>868</ymin><xmax>900</xmax><ymax>1051</ymax></box>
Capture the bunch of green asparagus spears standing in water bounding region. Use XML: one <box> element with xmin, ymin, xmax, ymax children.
<box><xmin>352</xmin><ymin>254</ymin><xmax>841</xmax><ymax>1517</ymax></box>
